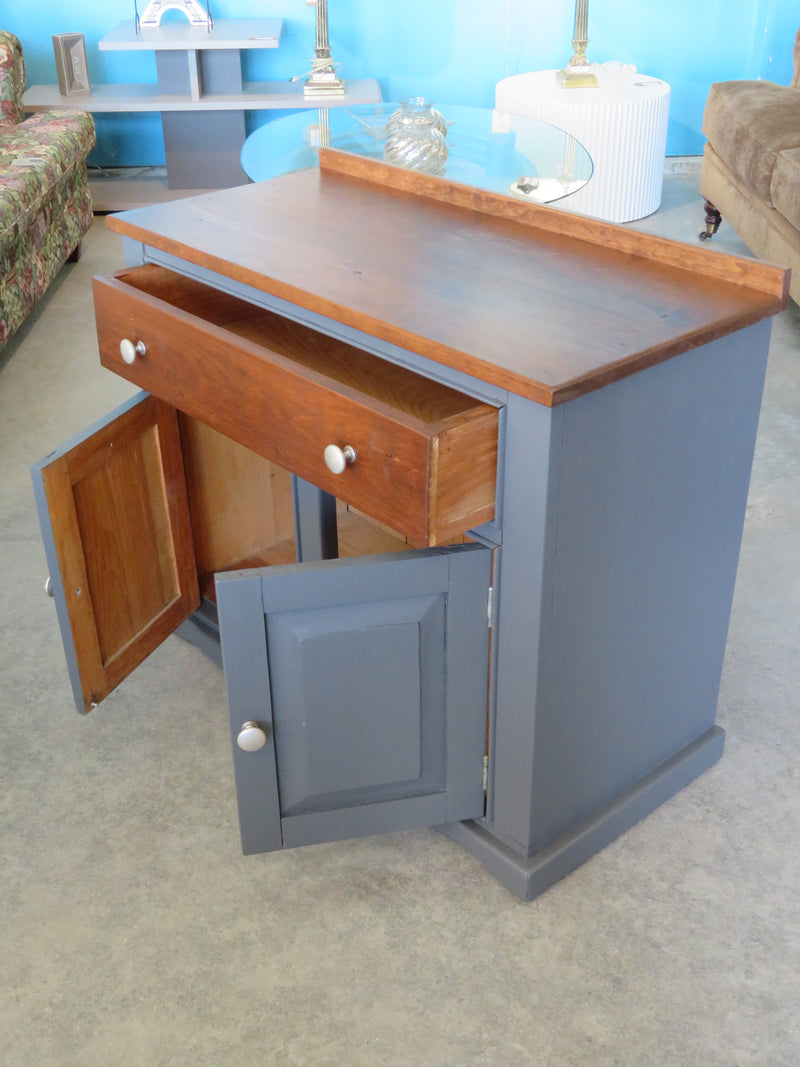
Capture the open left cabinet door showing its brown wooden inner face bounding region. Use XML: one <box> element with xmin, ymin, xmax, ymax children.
<box><xmin>32</xmin><ymin>394</ymin><xmax>199</xmax><ymax>711</ymax></box>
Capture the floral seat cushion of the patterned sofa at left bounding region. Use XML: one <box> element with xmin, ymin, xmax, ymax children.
<box><xmin>0</xmin><ymin>111</ymin><xmax>95</xmax><ymax>244</ymax></box>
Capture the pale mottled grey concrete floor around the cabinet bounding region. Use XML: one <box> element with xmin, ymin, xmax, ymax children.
<box><xmin>0</xmin><ymin>173</ymin><xmax>800</xmax><ymax>1067</ymax></box>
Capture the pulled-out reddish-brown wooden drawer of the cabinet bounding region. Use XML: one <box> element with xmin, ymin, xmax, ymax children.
<box><xmin>94</xmin><ymin>265</ymin><xmax>498</xmax><ymax>545</ymax></box>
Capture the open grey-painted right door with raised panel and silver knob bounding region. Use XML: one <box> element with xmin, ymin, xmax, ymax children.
<box><xmin>217</xmin><ymin>544</ymin><xmax>492</xmax><ymax>854</ymax></box>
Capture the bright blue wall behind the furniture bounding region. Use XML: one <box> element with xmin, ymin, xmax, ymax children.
<box><xmin>0</xmin><ymin>0</ymin><xmax>800</xmax><ymax>165</ymax></box>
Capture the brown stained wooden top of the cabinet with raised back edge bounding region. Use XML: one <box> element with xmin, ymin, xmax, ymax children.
<box><xmin>108</xmin><ymin>149</ymin><xmax>788</xmax><ymax>405</ymax></box>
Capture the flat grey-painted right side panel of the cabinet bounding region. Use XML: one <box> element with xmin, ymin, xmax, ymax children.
<box><xmin>531</xmin><ymin>322</ymin><xmax>769</xmax><ymax>848</ymax></box>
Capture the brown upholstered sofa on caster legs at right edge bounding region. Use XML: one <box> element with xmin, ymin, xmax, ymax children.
<box><xmin>700</xmin><ymin>30</ymin><xmax>800</xmax><ymax>302</ymax></box>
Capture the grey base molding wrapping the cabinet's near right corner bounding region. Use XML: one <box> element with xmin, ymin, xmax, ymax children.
<box><xmin>438</xmin><ymin>726</ymin><xmax>725</xmax><ymax>901</ymax></box>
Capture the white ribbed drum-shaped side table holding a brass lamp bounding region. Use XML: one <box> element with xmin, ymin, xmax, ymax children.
<box><xmin>495</xmin><ymin>70</ymin><xmax>670</xmax><ymax>222</ymax></box>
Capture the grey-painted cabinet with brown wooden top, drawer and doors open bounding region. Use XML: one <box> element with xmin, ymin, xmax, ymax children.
<box><xmin>33</xmin><ymin>149</ymin><xmax>787</xmax><ymax>898</ymax></box>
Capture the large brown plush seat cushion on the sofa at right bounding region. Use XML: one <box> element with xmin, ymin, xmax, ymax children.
<box><xmin>703</xmin><ymin>81</ymin><xmax>800</xmax><ymax>204</ymax></box>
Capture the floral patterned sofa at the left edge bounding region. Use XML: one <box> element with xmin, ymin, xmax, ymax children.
<box><xmin>0</xmin><ymin>30</ymin><xmax>95</xmax><ymax>349</ymax></box>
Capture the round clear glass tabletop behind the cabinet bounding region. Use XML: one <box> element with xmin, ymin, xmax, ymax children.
<box><xmin>241</xmin><ymin>103</ymin><xmax>592</xmax><ymax>204</ymax></box>
